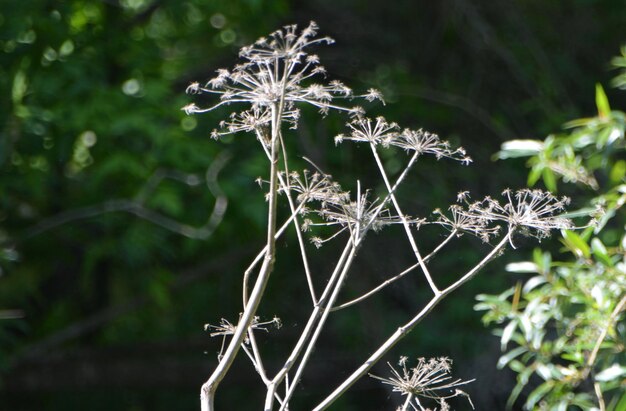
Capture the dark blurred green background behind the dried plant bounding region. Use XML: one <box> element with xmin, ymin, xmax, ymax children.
<box><xmin>0</xmin><ymin>0</ymin><xmax>626</xmax><ymax>411</ymax></box>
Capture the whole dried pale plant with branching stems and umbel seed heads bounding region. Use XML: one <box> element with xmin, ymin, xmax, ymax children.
<box><xmin>183</xmin><ymin>23</ymin><xmax>570</xmax><ymax>411</ymax></box>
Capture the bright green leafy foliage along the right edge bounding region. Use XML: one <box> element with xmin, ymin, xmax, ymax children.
<box><xmin>475</xmin><ymin>57</ymin><xmax>626</xmax><ymax>410</ymax></box>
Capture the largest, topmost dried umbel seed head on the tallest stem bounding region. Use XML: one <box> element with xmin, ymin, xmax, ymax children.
<box><xmin>178</xmin><ymin>22</ymin><xmax>382</xmax><ymax>137</ymax></box>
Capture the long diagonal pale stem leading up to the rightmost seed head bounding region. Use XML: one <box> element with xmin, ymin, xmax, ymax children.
<box><xmin>314</xmin><ymin>231</ymin><xmax>512</xmax><ymax>411</ymax></box>
